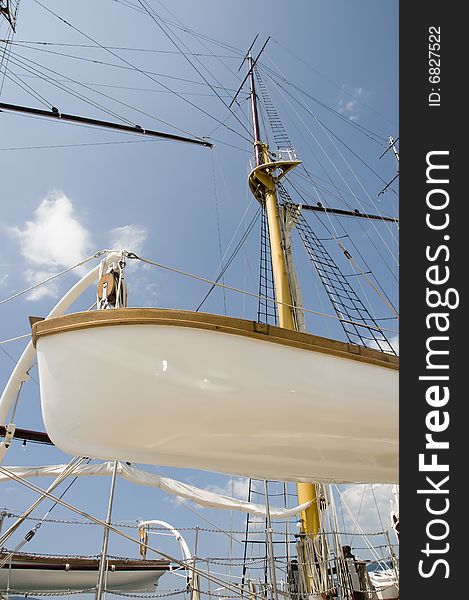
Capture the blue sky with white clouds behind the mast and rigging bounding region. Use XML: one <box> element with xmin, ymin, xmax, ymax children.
<box><xmin>0</xmin><ymin>0</ymin><xmax>398</xmax><ymax>580</ymax></box>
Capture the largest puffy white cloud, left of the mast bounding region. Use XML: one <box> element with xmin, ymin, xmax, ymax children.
<box><xmin>10</xmin><ymin>192</ymin><xmax>90</xmax><ymax>267</ymax></box>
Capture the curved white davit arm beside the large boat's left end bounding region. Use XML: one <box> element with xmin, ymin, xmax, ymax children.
<box><xmin>0</xmin><ymin>251</ymin><xmax>122</xmax><ymax>423</ymax></box>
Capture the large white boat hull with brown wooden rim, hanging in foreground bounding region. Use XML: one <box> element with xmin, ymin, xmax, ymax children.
<box><xmin>34</xmin><ymin>309</ymin><xmax>398</xmax><ymax>483</ymax></box>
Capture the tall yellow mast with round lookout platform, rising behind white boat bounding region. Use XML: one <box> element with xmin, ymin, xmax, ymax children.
<box><xmin>247</xmin><ymin>53</ymin><xmax>320</xmax><ymax>535</ymax></box>
